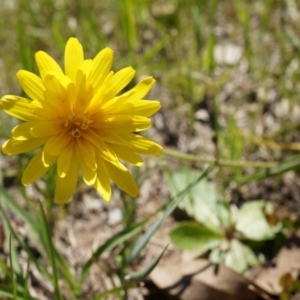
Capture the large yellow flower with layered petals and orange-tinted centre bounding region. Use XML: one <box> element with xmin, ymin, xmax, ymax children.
<box><xmin>0</xmin><ymin>38</ymin><xmax>162</xmax><ymax>204</ymax></box>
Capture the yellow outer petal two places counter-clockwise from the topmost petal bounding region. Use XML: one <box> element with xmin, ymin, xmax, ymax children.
<box><xmin>17</xmin><ymin>70</ymin><xmax>45</xmax><ymax>101</ymax></box>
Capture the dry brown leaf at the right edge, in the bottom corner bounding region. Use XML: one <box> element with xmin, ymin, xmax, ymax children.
<box><xmin>252</xmin><ymin>233</ymin><xmax>300</xmax><ymax>295</ymax></box>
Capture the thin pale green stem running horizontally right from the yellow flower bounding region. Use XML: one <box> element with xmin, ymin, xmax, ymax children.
<box><xmin>163</xmin><ymin>148</ymin><xmax>278</xmax><ymax>168</ymax></box>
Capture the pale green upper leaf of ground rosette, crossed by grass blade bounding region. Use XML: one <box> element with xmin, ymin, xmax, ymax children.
<box><xmin>169</xmin><ymin>169</ymin><xmax>231</xmax><ymax>232</ymax></box>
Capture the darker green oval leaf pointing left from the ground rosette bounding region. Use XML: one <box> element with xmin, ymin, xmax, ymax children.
<box><xmin>170</xmin><ymin>222</ymin><xmax>224</xmax><ymax>252</ymax></box>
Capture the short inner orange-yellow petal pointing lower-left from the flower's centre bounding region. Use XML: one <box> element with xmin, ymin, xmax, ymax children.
<box><xmin>44</xmin><ymin>133</ymin><xmax>73</xmax><ymax>156</ymax></box>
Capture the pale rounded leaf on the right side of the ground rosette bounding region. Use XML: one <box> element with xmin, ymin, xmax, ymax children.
<box><xmin>235</xmin><ymin>200</ymin><xmax>280</xmax><ymax>241</ymax></box>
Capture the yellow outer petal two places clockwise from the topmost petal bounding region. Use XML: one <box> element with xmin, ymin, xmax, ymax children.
<box><xmin>104</xmin><ymin>67</ymin><xmax>135</xmax><ymax>101</ymax></box>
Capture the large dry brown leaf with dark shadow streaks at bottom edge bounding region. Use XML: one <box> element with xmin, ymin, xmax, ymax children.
<box><xmin>150</xmin><ymin>259</ymin><xmax>268</xmax><ymax>300</ymax></box>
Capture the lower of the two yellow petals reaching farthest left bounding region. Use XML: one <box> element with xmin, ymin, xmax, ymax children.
<box><xmin>2</xmin><ymin>138</ymin><xmax>48</xmax><ymax>155</ymax></box>
